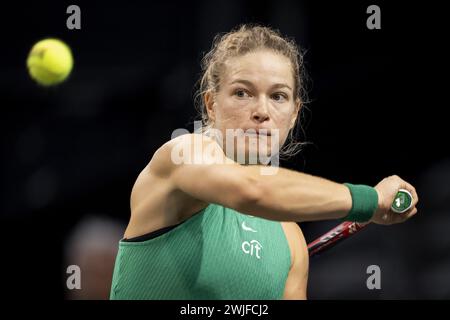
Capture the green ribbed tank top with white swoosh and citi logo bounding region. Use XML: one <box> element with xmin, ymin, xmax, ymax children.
<box><xmin>110</xmin><ymin>204</ymin><xmax>291</xmax><ymax>300</ymax></box>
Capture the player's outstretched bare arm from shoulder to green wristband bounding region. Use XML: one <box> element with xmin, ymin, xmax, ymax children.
<box><xmin>171</xmin><ymin>135</ymin><xmax>352</xmax><ymax>222</ymax></box>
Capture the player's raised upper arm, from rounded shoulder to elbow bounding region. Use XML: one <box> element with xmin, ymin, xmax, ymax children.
<box><xmin>155</xmin><ymin>134</ymin><xmax>255</xmax><ymax>210</ymax></box>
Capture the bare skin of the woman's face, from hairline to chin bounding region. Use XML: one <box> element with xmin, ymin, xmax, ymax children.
<box><xmin>205</xmin><ymin>50</ymin><xmax>301</xmax><ymax>162</ymax></box>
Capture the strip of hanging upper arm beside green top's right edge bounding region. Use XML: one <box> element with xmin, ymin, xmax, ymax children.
<box><xmin>283</xmin><ymin>222</ymin><xmax>309</xmax><ymax>300</ymax></box>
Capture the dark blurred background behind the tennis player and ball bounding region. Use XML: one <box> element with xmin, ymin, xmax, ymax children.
<box><xmin>0</xmin><ymin>0</ymin><xmax>450</xmax><ymax>299</ymax></box>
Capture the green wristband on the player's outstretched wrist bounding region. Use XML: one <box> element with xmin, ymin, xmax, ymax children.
<box><xmin>344</xmin><ymin>183</ymin><xmax>378</xmax><ymax>222</ymax></box>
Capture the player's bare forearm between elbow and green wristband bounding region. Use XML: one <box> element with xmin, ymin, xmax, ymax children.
<box><xmin>239</xmin><ymin>166</ymin><xmax>352</xmax><ymax>222</ymax></box>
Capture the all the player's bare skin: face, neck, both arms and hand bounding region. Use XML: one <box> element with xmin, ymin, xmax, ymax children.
<box><xmin>124</xmin><ymin>50</ymin><xmax>418</xmax><ymax>299</ymax></box>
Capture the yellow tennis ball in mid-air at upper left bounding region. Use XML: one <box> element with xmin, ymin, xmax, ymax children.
<box><xmin>27</xmin><ymin>39</ymin><xmax>73</xmax><ymax>86</ymax></box>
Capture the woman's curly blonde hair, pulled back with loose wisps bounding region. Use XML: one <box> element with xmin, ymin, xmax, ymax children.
<box><xmin>195</xmin><ymin>24</ymin><xmax>307</xmax><ymax>158</ymax></box>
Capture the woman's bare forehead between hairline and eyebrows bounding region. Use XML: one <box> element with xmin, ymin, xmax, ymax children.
<box><xmin>223</xmin><ymin>50</ymin><xmax>294</xmax><ymax>87</ymax></box>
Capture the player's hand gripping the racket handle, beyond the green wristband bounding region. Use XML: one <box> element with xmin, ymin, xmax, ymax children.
<box><xmin>370</xmin><ymin>176</ymin><xmax>419</xmax><ymax>225</ymax></box>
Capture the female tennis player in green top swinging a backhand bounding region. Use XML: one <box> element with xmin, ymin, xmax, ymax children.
<box><xmin>110</xmin><ymin>25</ymin><xmax>418</xmax><ymax>300</ymax></box>
